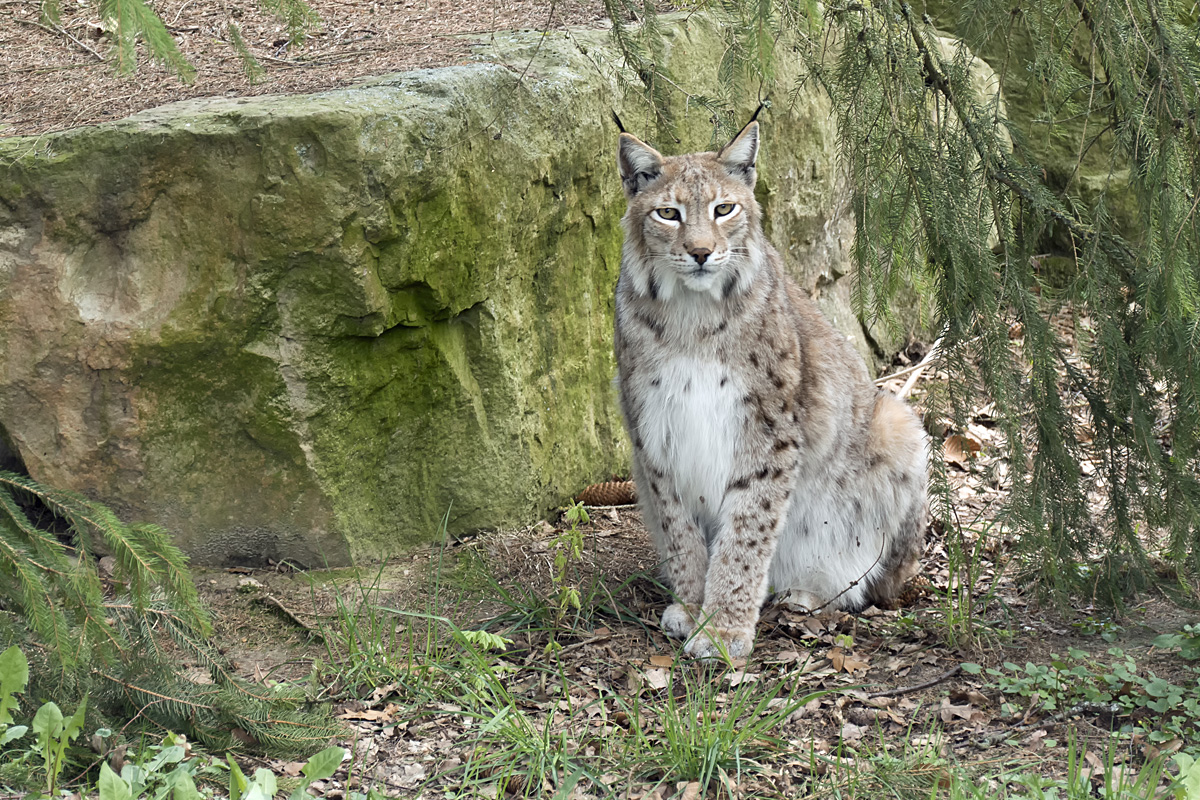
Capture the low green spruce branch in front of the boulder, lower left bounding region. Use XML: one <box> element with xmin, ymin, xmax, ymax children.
<box><xmin>0</xmin><ymin>471</ymin><xmax>338</xmax><ymax>754</ymax></box>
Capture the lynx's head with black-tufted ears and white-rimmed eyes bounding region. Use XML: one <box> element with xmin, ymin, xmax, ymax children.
<box><xmin>617</xmin><ymin>121</ymin><xmax>762</xmax><ymax>301</ymax></box>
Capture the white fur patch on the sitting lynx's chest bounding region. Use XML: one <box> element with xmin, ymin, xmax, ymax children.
<box><xmin>638</xmin><ymin>356</ymin><xmax>745</xmax><ymax>530</ymax></box>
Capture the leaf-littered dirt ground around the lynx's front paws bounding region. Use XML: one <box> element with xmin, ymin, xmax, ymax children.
<box><xmin>200</xmin><ymin>491</ymin><xmax>1196</xmax><ymax>800</ymax></box>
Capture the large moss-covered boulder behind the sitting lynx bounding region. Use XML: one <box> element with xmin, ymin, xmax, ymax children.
<box><xmin>0</xmin><ymin>17</ymin><xmax>866</xmax><ymax>566</ymax></box>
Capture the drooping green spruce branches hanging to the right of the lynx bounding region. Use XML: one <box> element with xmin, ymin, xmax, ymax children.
<box><xmin>604</xmin><ymin>0</ymin><xmax>1200</xmax><ymax>599</ymax></box>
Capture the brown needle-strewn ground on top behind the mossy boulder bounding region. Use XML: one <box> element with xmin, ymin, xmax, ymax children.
<box><xmin>0</xmin><ymin>0</ymin><xmax>605</xmax><ymax>136</ymax></box>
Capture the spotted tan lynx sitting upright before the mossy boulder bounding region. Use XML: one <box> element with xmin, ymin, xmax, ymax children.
<box><xmin>614</xmin><ymin>121</ymin><xmax>928</xmax><ymax>658</ymax></box>
